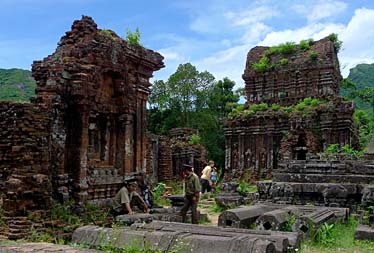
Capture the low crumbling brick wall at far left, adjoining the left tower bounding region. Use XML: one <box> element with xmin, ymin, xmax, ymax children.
<box><xmin>0</xmin><ymin>102</ymin><xmax>52</xmax><ymax>216</ymax></box>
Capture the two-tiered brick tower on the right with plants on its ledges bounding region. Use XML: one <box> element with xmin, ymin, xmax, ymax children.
<box><xmin>225</xmin><ymin>38</ymin><xmax>354</xmax><ymax>175</ymax></box>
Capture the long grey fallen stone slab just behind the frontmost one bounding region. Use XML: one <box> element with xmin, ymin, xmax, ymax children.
<box><xmin>132</xmin><ymin>221</ymin><xmax>301</xmax><ymax>252</ymax></box>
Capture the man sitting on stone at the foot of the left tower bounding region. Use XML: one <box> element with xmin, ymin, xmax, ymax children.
<box><xmin>113</xmin><ymin>181</ymin><xmax>148</xmax><ymax>215</ymax></box>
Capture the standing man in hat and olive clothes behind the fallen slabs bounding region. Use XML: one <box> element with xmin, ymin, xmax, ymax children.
<box><xmin>180</xmin><ymin>164</ymin><xmax>201</xmax><ymax>224</ymax></box>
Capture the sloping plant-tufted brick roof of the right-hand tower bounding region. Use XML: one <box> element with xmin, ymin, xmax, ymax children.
<box><xmin>243</xmin><ymin>37</ymin><xmax>340</xmax><ymax>81</ymax></box>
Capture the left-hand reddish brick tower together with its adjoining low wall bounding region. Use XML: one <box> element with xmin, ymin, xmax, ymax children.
<box><xmin>0</xmin><ymin>16</ymin><xmax>164</xmax><ymax>215</ymax></box>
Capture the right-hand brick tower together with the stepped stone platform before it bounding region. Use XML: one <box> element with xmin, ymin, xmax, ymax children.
<box><xmin>224</xmin><ymin>38</ymin><xmax>374</xmax><ymax>212</ymax></box>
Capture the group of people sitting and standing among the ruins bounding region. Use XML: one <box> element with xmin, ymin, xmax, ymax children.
<box><xmin>113</xmin><ymin>161</ymin><xmax>218</xmax><ymax>224</ymax></box>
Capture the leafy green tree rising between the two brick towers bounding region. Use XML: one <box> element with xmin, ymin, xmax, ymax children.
<box><xmin>148</xmin><ymin>63</ymin><xmax>239</xmax><ymax>169</ymax></box>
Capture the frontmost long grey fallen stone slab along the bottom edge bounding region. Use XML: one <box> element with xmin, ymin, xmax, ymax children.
<box><xmin>72</xmin><ymin>226</ymin><xmax>276</xmax><ymax>253</ymax></box>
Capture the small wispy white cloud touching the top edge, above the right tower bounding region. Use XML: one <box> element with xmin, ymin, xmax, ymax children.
<box><xmin>291</xmin><ymin>0</ymin><xmax>348</xmax><ymax>23</ymax></box>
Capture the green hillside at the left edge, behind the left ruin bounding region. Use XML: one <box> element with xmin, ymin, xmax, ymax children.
<box><xmin>0</xmin><ymin>69</ymin><xmax>36</xmax><ymax>101</ymax></box>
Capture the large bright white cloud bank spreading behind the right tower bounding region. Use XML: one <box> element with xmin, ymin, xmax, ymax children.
<box><xmin>154</xmin><ymin>1</ymin><xmax>374</xmax><ymax>87</ymax></box>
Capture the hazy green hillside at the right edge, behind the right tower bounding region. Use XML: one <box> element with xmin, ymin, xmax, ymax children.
<box><xmin>341</xmin><ymin>63</ymin><xmax>374</xmax><ymax>114</ymax></box>
